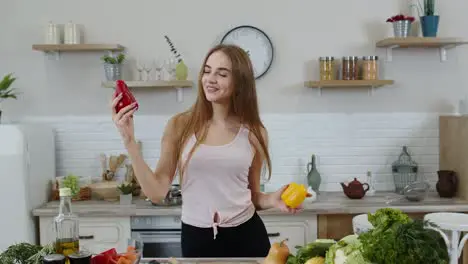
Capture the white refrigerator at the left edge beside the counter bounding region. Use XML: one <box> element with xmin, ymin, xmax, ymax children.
<box><xmin>0</xmin><ymin>124</ymin><xmax>55</xmax><ymax>252</ymax></box>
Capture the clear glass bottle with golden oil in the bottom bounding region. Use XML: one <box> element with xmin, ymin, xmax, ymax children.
<box><xmin>54</xmin><ymin>188</ymin><xmax>79</xmax><ymax>256</ymax></box>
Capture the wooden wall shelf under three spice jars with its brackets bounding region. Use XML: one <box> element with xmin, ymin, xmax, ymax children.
<box><xmin>304</xmin><ymin>80</ymin><xmax>394</xmax><ymax>95</ymax></box>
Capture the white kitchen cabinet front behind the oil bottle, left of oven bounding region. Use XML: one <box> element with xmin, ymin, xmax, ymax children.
<box><xmin>39</xmin><ymin>217</ymin><xmax>131</xmax><ymax>253</ymax></box>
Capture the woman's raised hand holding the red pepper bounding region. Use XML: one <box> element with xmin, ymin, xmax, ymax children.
<box><xmin>111</xmin><ymin>94</ymin><xmax>136</xmax><ymax>145</ymax></box>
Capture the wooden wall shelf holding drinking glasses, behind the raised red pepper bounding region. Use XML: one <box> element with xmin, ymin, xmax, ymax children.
<box><xmin>102</xmin><ymin>80</ymin><xmax>194</xmax><ymax>102</ymax></box>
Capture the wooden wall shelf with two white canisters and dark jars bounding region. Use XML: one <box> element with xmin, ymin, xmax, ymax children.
<box><xmin>32</xmin><ymin>44</ymin><xmax>125</xmax><ymax>52</ymax></box>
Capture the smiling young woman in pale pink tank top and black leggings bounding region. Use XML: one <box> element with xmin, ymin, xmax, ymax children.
<box><xmin>112</xmin><ymin>45</ymin><xmax>308</xmax><ymax>257</ymax></box>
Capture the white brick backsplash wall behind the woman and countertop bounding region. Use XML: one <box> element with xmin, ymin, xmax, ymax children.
<box><xmin>21</xmin><ymin>113</ymin><xmax>438</xmax><ymax>191</ymax></box>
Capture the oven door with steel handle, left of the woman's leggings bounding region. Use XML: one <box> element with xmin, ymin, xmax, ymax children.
<box><xmin>132</xmin><ymin>229</ymin><xmax>182</xmax><ymax>259</ymax></box>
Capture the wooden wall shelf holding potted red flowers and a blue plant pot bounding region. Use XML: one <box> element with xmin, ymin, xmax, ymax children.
<box><xmin>376</xmin><ymin>37</ymin><xmax>468</xmax><ymax>61</ymax></box>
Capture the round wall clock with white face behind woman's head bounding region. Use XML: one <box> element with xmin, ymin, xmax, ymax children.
<box><xmin>221</xmin><ymin>25</ymin><xmax>274</xmax><ymax>79</ymax></box>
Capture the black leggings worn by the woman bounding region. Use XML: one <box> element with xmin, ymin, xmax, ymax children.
<box><xmin>181</xmin><ymin>213</ymin><xmax>270</xmax><ymax>258</ymax></box>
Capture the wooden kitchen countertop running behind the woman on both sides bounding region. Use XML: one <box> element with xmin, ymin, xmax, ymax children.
<box><xmin>33</xmin><ymin>192</ymin><xmax>468</xmax><ymax>217</ymax></box>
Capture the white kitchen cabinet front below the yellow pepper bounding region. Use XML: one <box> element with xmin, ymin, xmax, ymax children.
<box><xmin>261</xmin><ymin>213</ymin><xmax>317</xmax><ymax>253</ymax></box>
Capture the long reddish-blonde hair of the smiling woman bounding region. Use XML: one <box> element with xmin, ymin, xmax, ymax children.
<box><xmin>175</xmin><ymin>44</ymin><xmax>271</xmax><ymax>184</ymax></box>
